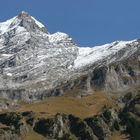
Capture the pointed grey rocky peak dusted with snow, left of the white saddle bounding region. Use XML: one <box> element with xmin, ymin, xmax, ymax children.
<box><xmin>0</xmin><ymin>12</ymin><xmax>78</xmax><ymax>90</ymax></box>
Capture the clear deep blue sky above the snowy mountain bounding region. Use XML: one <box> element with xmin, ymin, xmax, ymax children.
<box><xmin>0</xmin><ymin>0</ymin><xmax>140</xmax><ymax>46</ymax></box>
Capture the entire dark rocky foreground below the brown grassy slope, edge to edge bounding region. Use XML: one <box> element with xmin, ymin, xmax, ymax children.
<box><xmin>0</xmin><ymin>91</ymin><xmax>140</xmax><ymax>140</ymax></box>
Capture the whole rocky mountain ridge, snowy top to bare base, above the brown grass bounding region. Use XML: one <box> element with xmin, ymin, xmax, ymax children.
<box><xmin>0</xmin><ymin>12</ymin><xmax>140</xmax><ymax>101</ymax></box>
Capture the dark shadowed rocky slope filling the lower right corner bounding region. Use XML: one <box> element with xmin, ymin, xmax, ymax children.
<box><xmin>120</xmin><ymin>92</ymin><xmax>140</xmax><ymax>140</ymax></box>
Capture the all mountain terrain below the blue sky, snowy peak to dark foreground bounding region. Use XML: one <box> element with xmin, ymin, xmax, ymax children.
<box><xmin>0</xmin><ymin>12</ymin><xmax>140</xmax><ymax>140</ymax></box>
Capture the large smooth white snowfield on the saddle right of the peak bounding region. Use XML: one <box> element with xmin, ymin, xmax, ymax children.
<box><xmin>74</xmin><ymin>40</ymin><xmax>136</xmax><ymax>68</ymax></box>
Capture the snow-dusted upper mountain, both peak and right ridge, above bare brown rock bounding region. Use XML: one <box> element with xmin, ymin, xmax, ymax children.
<box><xmin>0</xmin><ymin>11</ymin><xmax>140</xmax><ymax>100</ymax></box>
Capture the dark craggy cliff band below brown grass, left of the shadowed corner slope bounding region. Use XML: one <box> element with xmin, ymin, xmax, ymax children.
<box><xmin>0</xmin><ymin>110</ymin><xmax>119</xmax><ymax>140</ymax></box>
